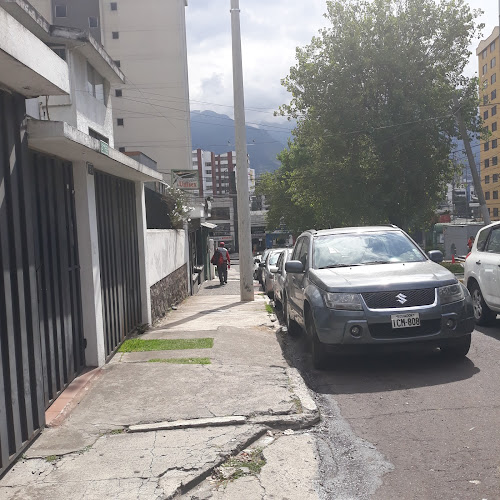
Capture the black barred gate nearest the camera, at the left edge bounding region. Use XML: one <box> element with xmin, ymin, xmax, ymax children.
<box><xmin>0</xmin><ymin>91</ymin><xmax>45</xmax><ymax>474</ymax></box>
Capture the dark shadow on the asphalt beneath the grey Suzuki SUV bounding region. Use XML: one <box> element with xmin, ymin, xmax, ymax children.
<box><xmin>277</xmin><ymin>317</ymin><xmax>480</xmax><ymax>394</ymax></box>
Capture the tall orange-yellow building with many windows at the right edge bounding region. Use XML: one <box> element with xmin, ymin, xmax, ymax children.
<box><xmin>476</xmin><ymin>26</ymin><xmax>500</xmax><ymax>220</ymax></box>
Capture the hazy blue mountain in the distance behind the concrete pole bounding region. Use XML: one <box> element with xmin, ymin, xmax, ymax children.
<box><xmin>191</xmin><ymin>111</ymin><xmax>289</xmax><ymax>175</ymax></box>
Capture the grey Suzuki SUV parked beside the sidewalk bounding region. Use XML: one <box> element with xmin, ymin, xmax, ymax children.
<box><xmin>283</xmin><ymin>226</ymin><xmax>474</xmax><ymax>368</ymax></box>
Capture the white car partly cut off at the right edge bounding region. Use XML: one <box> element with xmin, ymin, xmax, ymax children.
<box><xmin>464</xmin><ymin>222</ymin><xmax>500</xmax><ymax>325</ymax></box>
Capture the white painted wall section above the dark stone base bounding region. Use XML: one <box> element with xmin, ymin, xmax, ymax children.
<box><xmin>146</xmin><ymin>229</ymin><xmax>186</xmax><ymax>286</ymax></box>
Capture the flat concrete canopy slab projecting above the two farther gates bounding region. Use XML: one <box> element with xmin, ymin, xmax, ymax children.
<box><xmin>28</xmin><ymin>120</ymin><xmax>163</xmax><ymax>182</ymax></box>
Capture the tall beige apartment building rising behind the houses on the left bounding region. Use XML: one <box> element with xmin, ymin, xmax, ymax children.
<box><xmin>33</xmin><ymin>0</ymin><xmax>192</xmax><ymax>173</ymax></box>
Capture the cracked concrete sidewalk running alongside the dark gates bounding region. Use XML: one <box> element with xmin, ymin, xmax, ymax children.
<box><xmin>0</xmin><ymin>266</ymin><xmax>319</xmax><ymax>500</ymax></box>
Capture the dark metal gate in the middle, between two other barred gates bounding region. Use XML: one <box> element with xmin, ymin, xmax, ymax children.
<box><xmin>31</xmin><ymin>154</ymin><xmax>85</xmax><ymax>407</ymax></box>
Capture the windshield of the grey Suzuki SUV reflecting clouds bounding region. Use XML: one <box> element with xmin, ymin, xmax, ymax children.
<box><xmin>314</xmin><ymin>231</ymin><xmax>426</xmax><ymax>269</ymax></box>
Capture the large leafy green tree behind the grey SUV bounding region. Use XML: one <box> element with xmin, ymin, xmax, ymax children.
<box><xmin>260</xmin><ymin>0</ymin><xmax>481</xmax><ymax>232</ymax></box>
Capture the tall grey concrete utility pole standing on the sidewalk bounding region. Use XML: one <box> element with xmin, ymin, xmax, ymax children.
<box><xmin>231</xmin><ymin>0</ymin><xmax>254</xmax><ymax>301</ymax></box>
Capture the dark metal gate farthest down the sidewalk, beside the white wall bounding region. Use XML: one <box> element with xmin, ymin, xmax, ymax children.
<box><xmin>95</xmin><ymin>171</ymin><xmax>141</xmax><ymax>357</ymax></box>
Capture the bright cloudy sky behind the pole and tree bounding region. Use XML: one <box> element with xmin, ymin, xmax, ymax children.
<box><xmin>186</xmin><ymin>0</ymin><xmax>498</xmax><ymax>129</ymax></box>
